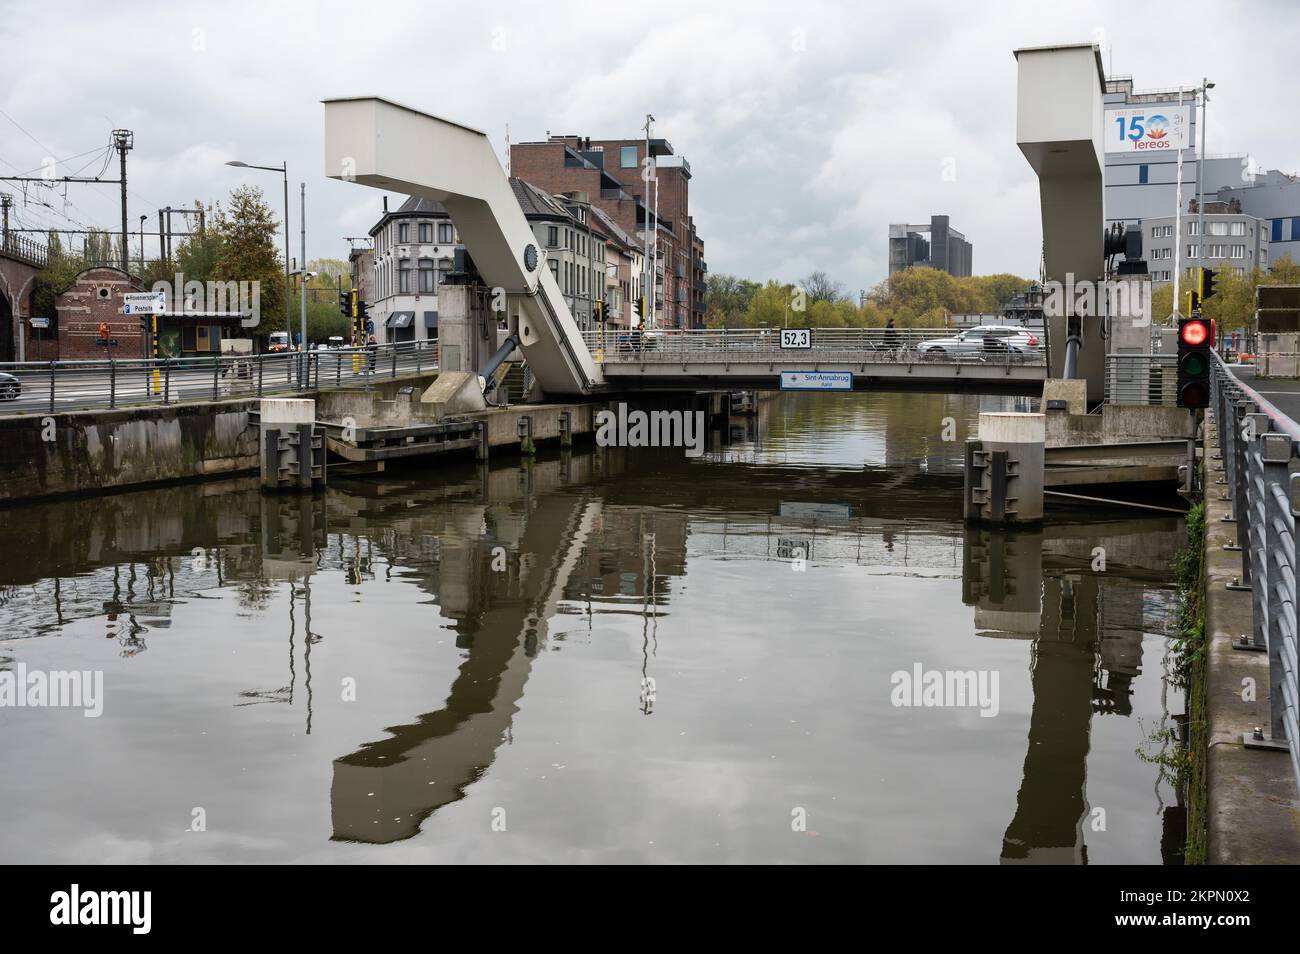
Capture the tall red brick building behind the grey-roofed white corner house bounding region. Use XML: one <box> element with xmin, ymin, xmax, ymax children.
<box><xmin>510</xmin><ymin>135</ymin><xmax>707</xmax><ymax>328</ymax></box>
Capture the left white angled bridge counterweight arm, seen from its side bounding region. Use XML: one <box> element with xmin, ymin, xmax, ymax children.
<box><xmin>325</xmin><ymin>96</ymin><xmax>603</xmax><ymax>394</ymax></box>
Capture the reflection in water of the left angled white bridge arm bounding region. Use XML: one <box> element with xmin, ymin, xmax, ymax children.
<box><xmin>330</xmin><ymin>454</ymin><xmax>608</xmax><ymax>844</ymax></box>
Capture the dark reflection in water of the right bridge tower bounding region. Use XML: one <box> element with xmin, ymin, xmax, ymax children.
<box><xmin>962</xmin><ymin>519</ymin><xmax>1183</xmax><ymax>864</ymax></box>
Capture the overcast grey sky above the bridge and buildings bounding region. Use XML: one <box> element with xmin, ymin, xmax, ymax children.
<box><xmin>0</xmin><ymin>0</ymin><xmax>1300</xmax><ymax>291</ymax></box>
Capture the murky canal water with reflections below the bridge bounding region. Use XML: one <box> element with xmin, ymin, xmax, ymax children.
<box><xmin>0</xmin><ymin>395</ymin><xmax>1183</xmax><ymax>863</ymax></box>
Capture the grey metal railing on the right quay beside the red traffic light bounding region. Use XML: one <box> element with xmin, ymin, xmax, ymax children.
<box><xmin>1206</xmin><ymin>355</ymin><xmax>1300</xmax><ymax>785</ymax></box>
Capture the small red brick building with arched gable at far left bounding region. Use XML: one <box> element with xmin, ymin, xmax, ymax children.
<box><xmin>54</xmin><ymin>265</ymin><xmax>147</xmax><ymax>361</ymax></box>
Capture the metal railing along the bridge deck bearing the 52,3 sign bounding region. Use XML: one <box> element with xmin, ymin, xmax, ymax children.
<box><xmin>582</xmin><ymin>328</ymin><xmax>1044</xmax><ymax>364</ymax></box>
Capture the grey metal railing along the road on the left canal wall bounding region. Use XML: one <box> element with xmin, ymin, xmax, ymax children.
<box><xmin>0</xmin><ymin>341</ymin><xmax>438</xmax><ymax>415</ymax></box>
